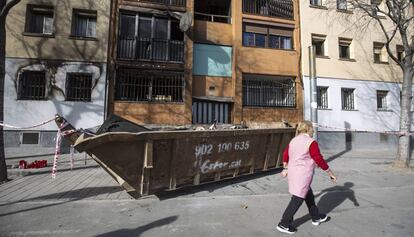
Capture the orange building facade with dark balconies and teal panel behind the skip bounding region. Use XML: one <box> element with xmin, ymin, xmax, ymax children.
<box><xmin>108</xmin><ymin>0</ymin><xmax>303</xmax><ymax>125</ymax></box>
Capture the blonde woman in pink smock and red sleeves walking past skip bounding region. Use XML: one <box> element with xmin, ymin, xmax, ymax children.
<box><xmin>276</xmin><ymin>121</ymin><xmax>337</xmax><ymax>234</ymax></box>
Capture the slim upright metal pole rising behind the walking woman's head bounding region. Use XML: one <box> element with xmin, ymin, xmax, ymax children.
<box><xmin>309</xmin><ymin>46</ymin><xmax>318</xmax><ymax>140</ymax></box>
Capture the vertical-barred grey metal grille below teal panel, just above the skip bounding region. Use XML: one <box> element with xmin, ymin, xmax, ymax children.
<box><xmin>192</xmin><ymin>100</ymin><xmax>230</xmax><ymax>124</ymax></box>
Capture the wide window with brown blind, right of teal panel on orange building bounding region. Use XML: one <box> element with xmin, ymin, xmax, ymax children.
<box><xmin>243</xmin><ymin>22</ymin><xmax>294</xmax><ymax>50</ymax></box>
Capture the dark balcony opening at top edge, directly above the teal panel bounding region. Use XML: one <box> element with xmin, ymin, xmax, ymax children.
<box><xmin>194</xmin><ymin>0</ymin><xmax>231</xmax><ymax>24</ymax></box>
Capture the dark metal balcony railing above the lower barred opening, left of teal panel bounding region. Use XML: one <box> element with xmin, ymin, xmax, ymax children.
<box><xmin>118</xmin><ymin>37</ymin><xmax>184</xmax><ymax>62</ymax></box>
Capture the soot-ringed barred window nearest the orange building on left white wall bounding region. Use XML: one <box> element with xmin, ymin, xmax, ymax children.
<box><xmin>66</xmin><ymin>73</ymin><xmax>92</xmax><ymax>101</ymax></box>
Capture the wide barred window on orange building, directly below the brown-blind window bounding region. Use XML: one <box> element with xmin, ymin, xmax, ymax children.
<box><xmin>243</xmin><ymin>74</ymin><xmax>296</xmax><ymax>107</ymax></box>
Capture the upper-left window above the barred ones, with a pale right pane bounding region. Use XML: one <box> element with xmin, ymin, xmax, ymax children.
<box><xmin>25</xmin><ymin>5</ymin><xmax>54</xmax><ymax>35</ymax></box>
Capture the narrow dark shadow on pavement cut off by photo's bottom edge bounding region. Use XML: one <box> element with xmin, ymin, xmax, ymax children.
<box><xmin>96</xmin><ymin>216</ymin><xmax>178</xmax><ymax>237</ymax></box>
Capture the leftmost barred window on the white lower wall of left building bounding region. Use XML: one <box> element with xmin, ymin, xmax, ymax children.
<box><xmin>17</xmin><ymin>71</ymin><xmax>46</xmax><ymax>100</ymax></box>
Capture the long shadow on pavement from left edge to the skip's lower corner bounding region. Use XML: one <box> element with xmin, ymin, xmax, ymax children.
<box><xmin>0</xmin><ymin>186</ymin><xmax>121</xmax><ymax>217</ymax></box>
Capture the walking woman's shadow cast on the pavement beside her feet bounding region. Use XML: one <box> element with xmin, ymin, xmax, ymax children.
<box><xmin>293</xmin><ymin>182</ymin><xmax>359</xmax><ymax>227</ymax></box>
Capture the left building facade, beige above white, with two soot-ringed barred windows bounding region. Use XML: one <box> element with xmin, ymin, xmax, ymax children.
<box><xmin>4</xmin><ymin>0</ymin><xmax>110</xmax><ymax>155</ymax></box>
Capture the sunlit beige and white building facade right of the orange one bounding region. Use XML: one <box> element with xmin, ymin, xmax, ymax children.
<box><xmin>300</xmin><ymin>0</ymin><xmax>410</xmax><ymax>149</ymax></box>
